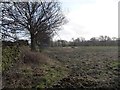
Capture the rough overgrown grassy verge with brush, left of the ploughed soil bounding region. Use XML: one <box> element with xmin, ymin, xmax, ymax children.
<box><xmin>2</xmin><ymin>47</ymin><xmax>69</xmax><ymax>88</ymax></box>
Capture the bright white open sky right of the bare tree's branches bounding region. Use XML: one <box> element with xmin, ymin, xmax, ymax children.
<box><xmin>54</xmin><ymin>0</ymin><xmax>119</xmax><ymax>41</ymax></box>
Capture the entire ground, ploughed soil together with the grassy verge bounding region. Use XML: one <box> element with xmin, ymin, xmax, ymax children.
<box><xmin>2</xmin><ymin>46</ymin><xmax>120</xmax><ymax>88</ymax></box>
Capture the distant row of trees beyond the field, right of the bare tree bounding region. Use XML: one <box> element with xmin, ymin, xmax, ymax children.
<box><xmin>50</xmin><ymin>36</ymin><xmax>120</xmax><ymax>47</ymax></box>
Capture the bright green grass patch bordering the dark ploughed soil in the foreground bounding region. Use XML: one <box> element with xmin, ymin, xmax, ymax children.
<box><xmin>37</xmin><ymin>65</ymin><xmax>68</xmax><ymax>88</ymax></box>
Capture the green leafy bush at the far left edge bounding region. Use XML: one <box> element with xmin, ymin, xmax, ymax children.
<box><xmin>2</xmin><ymin>46</ymin><xmax>19</xmax><ymax>71</ymax></box>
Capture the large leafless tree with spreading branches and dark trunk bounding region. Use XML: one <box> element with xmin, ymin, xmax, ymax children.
<box><xmin>2</xmin><ymin>1</ymin><xmax>66</xmax><ymax>51</ymax></box>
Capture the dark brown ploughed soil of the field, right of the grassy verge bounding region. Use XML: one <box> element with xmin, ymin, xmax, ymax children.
<box><xmin>44</xmin><ymin>46</ymin><xmax>120</xmax><ymax>88</ymax></box>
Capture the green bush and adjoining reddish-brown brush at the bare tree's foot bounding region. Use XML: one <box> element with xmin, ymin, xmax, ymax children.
<box><xmin>2</xmin><ymin>46</ymin><xmax>48</xmax><ymax>71</ymax></box>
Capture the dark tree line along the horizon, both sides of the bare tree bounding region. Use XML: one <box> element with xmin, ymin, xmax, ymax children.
<box><xmin>2</xmin><ymin>35</ymin><xmax>120</xmax><ymax>48</ymax></box>
